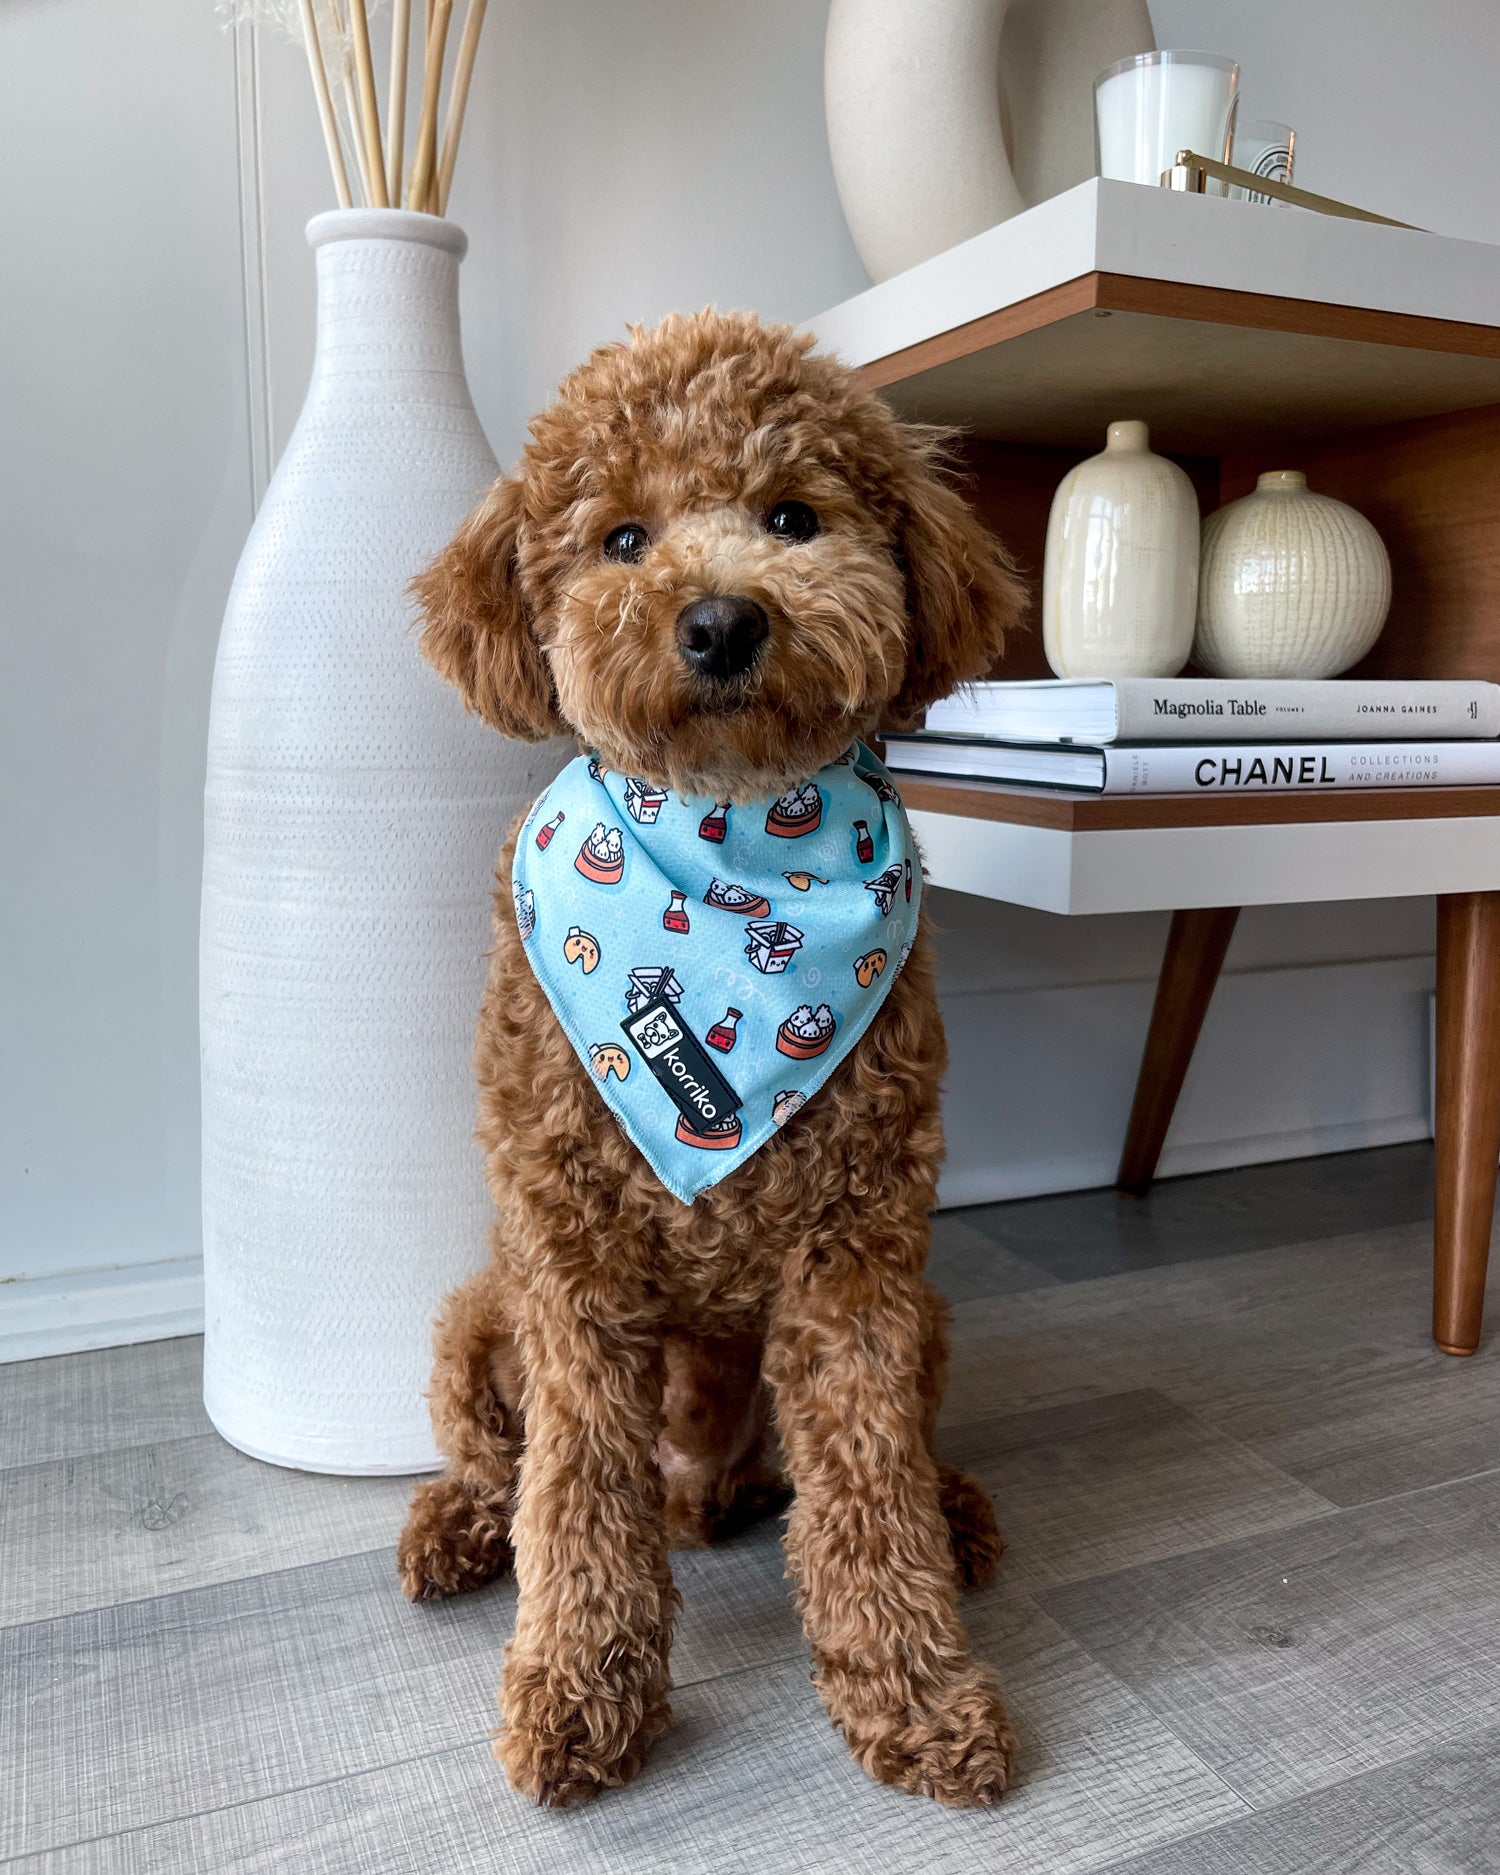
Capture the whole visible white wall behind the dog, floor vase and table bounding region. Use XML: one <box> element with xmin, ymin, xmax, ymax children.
<box><xmin>0</xmin><ymin>0</ymin><xmax>1500</xmax><ymax>1343</ymax></box>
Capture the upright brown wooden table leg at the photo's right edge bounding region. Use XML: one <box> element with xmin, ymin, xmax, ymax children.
<box><xmin>1433</xmin><ymin>893</ymin><xmax>1500</xmax><ymax>1354</ymax></box>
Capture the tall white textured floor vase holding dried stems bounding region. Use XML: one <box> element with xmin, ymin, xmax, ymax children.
<box><xmin>201</xmin><ymin>210</ymin><xmax>563</xmax><ymax>1472</ymax></box>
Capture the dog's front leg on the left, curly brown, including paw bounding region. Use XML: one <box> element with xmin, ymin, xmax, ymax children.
<box><xmin>495</xmin><ymin>1283</ymin><xmax>675</xmax><ymax>1806</ymax></box>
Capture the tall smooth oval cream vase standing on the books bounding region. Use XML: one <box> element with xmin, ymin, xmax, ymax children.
<box><xmin>1043</xmin><ymin>422</ymin><xmax>1198</xmax><ymax>677</ymax></box>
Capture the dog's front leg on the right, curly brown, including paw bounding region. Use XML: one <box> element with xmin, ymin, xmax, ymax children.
<box><xmin>767</xmin><ymin>1247</ymin><xmax>1011</xmax><ymax>1806</ymax></box>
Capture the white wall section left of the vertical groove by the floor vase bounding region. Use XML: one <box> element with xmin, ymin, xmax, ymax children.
<box><xmin>0</xmin><ymin>0</ymin><xmax>251</xmax><ymax>1350</ymax></box>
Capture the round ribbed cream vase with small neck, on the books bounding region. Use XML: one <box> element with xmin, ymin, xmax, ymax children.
<box><xmin>1193</xmin><ymin>469</ymin><xmax>1391</xmax><ymax>677</ymax></box>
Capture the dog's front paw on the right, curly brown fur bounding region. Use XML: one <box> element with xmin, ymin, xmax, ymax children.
<box><xmin>834</xmin><ymin>1669</ymin><xmax>1016</xmax><ymax>1809</ymax></box>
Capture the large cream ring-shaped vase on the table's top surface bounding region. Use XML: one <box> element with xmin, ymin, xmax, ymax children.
<box><xmin>823</xmin><ymin>0</ymin><xmax>1155</xmax><ymax>279</ymax></box>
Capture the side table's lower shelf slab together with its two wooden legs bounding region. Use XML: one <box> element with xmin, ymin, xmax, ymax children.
<box><xmin>898</xmin><ymin>774</ymin><xmax>1500</xmax><ymax>1354</ymax></box>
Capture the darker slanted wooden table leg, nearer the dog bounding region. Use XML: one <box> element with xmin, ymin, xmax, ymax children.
<box><xmin>1116</xmin><ymin>906</ymin><xmax>1239</xmax><ymax>1196</ymax></box>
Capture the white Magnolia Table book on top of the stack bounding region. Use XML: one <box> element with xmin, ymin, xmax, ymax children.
<box><xmin>926</xmin><ymin>677</ymin><xmax>1500</xmax><ymax>748</ymax></box>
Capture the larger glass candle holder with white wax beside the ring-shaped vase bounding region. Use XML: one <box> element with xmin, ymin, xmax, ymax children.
<box><xmin>1093</xmin><ymin>53</ymin><xmax>1239</xmax><ymax>189</ymax></box>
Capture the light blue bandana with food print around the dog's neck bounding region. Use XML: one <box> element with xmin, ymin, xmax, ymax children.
<box><xmin>512</xmin><ymin>743</ymin><xmax>923</xmax><ymax>1204</ymax></box>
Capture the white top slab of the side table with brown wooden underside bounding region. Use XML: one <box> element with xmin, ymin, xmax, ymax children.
<box><xmin>810</xmin><ymin>180</ymin><xmax>1500</xmax><ymax>461</ymax></box>
